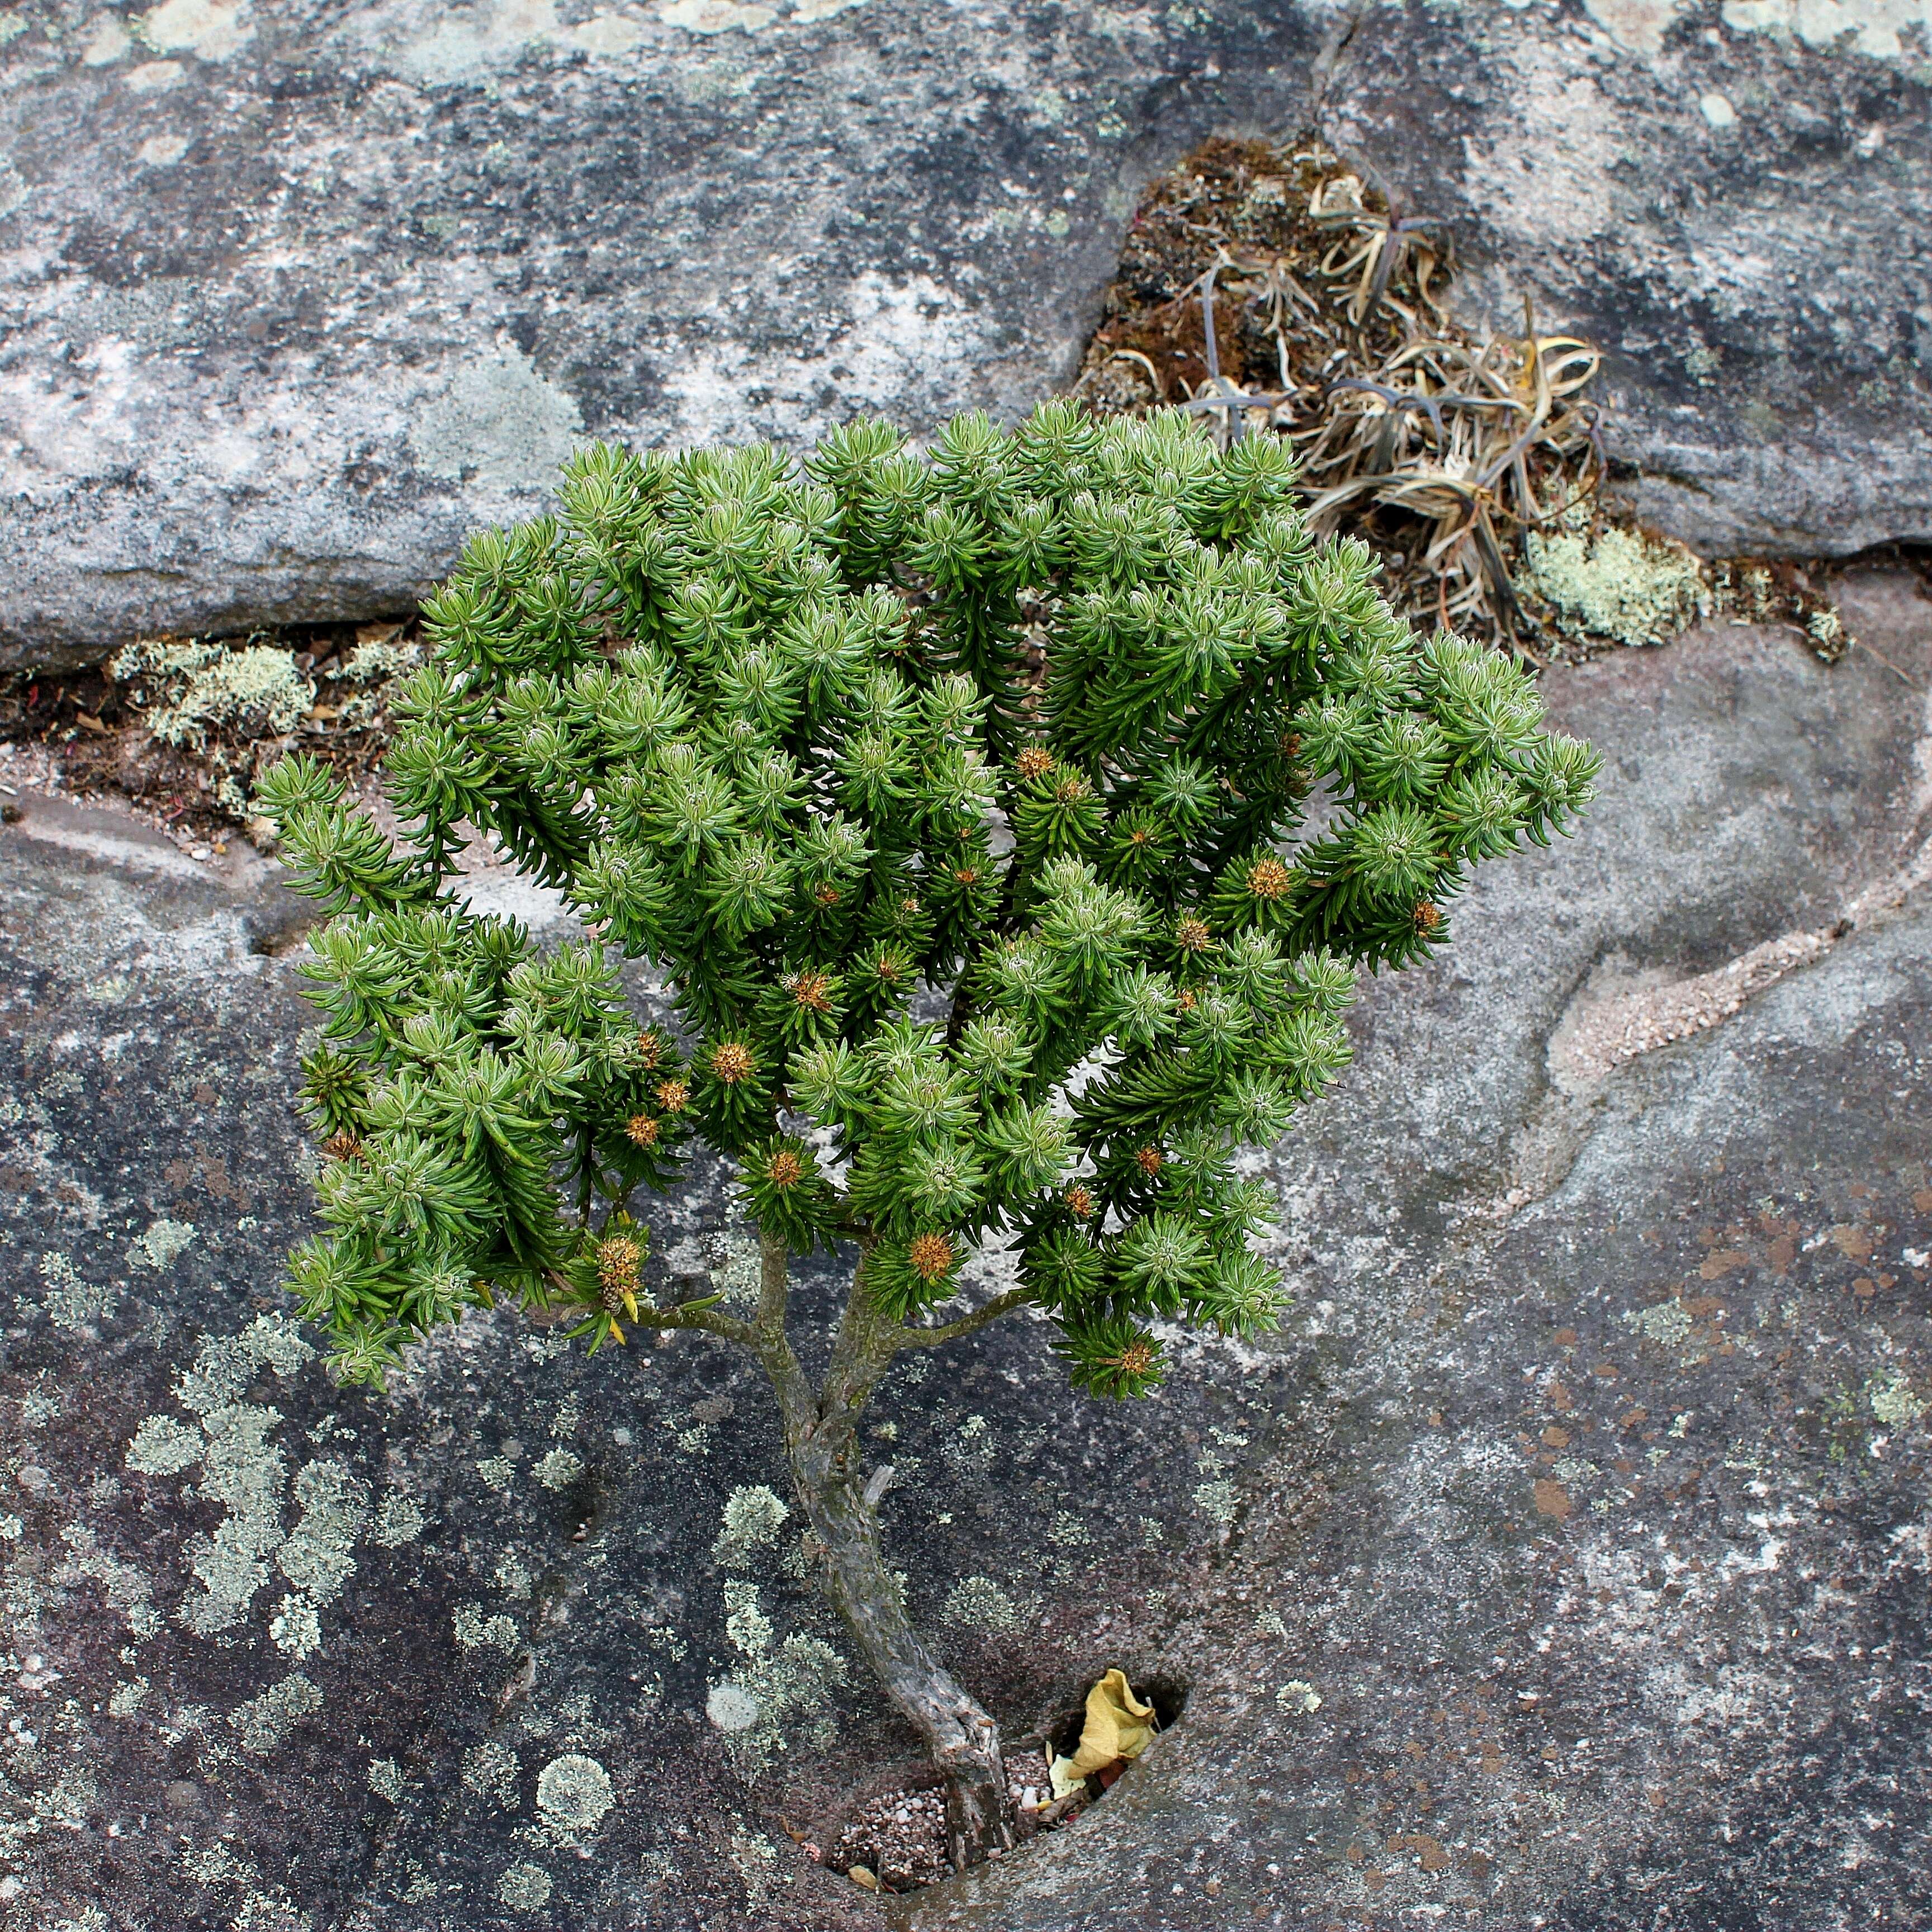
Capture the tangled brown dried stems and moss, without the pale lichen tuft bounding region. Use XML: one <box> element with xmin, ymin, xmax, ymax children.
<box><xmin>1076</xmin><ymin>141</ymin><xmax>1603</xmax><ymax>641</ymax></box>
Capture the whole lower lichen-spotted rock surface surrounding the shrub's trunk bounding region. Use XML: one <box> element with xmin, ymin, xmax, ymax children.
<box><xmin>0</xmin><ymin>574</ymin><xmax>1932</xmax><ymax>1932</ymax></box>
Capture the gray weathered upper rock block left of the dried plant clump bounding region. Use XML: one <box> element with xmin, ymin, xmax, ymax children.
<box><xmin>0</xmin><ymin>0</ymin><xmax>1319</xmax><ymax>653</ymax></box>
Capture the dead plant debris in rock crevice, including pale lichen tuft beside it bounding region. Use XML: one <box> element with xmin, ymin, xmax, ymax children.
<box><xmin>1074</xmin><ymin>137</ymin><xmax>1849</xmax><ymax>662</ymax></box>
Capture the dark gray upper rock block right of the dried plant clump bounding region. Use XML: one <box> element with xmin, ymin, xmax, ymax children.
<box><xmin>1319</xmin><ymin>0</ymin><xmax>1932</xmax><ymax>556</ymax></box>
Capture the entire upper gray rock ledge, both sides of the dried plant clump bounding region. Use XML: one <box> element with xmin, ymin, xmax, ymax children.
<box><xmin>0</xmin><ymin>0</ymin><xmax>1932</xmax><ymax>665</ymax></box>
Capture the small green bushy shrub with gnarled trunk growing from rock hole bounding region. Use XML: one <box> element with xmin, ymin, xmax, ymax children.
<box><xmin>261</xmin><ymin>402</ymin><xmax>1596</xmax><ymax>1864</ymax></box>
